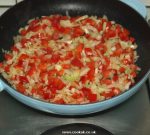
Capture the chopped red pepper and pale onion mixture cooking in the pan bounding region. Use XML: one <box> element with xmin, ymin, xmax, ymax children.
<box><xmin>0</xmin><ymin>15</ymin><xmax>140</xmax><ymax>104</ymax></box>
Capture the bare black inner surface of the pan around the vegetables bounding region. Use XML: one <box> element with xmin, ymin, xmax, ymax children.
<box><xmin>0</xmin><ymin>0</ymin><xmax>150</xmax><ymax>86</ymax></box>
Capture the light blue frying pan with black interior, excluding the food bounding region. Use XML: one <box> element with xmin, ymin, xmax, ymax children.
<box><xmin>0</xmin><ymin>0</ymin><xmax>150</xmax><ymax>115</ymax></box>
